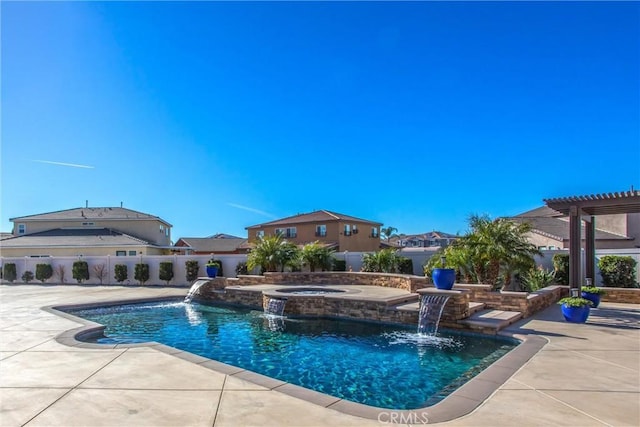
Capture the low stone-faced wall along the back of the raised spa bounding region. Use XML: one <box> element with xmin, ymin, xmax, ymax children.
<box><xmin>264</xmin><ymin>271</ymin><xmax>427</xmax><ymax>292</ymax></box>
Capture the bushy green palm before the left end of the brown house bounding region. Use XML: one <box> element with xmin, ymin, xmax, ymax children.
<box><xmin>247</xmin><ymin>235</ymin><xmax>300</xmax><ymax>271</ymax></box>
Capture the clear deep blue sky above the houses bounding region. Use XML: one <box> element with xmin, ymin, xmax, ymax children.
<box><xmin>0</xmin><ymin>1</ymin><xmax>640</xmax><ymax>240</ymax></box>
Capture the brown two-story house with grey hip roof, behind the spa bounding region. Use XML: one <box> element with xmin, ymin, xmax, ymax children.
<box><xmin>246</xmin><ymin>210</ymin><xmax>382</xmax><ymax>252</ymax></box>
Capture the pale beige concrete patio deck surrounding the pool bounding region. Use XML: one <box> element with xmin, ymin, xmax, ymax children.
<box><xmin>0</xmin><ymin>285</ymin><xmax>640</xmax><ymax>427</ymax></box>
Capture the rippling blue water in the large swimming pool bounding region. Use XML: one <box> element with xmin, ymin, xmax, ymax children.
<box><xmin>69</xmin><ymin>302</ymin><xmax>516</xmax><ymax>409</ymax></box>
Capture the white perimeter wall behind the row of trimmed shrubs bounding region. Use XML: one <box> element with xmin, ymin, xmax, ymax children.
<box><xmin>0</xmin><ymin>248</ymin><xmax>640</xmax><ymax>286</ymax></box>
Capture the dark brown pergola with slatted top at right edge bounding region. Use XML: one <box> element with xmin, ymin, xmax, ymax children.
<box><xmin>544</xmin><ymin>191</ymin><xmax>640</xmax><ymax>295</ymax></box>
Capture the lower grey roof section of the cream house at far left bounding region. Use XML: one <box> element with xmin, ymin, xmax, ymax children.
<box><xmin>0</xmin><ymin>228</ymin><xmax>153</xmax><ymax>248</ymax></box>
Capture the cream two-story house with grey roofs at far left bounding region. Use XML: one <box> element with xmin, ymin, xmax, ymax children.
<box><xmin>0</xmin><ymin>206</ymin><xmax>172</xmax><ymax>257</ymax></box>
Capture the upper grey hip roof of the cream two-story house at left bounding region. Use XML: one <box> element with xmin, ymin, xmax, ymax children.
<box><xmin>9</xmin><ymin>207</ymin><xmax>171</xmax><ymax>226</ymax></box>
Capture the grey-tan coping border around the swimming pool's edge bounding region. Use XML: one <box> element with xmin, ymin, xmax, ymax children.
<box><xmin>42</xmin><ymin>296</ymin><xmax>549</xmax><ymax>424</ymax></box>
